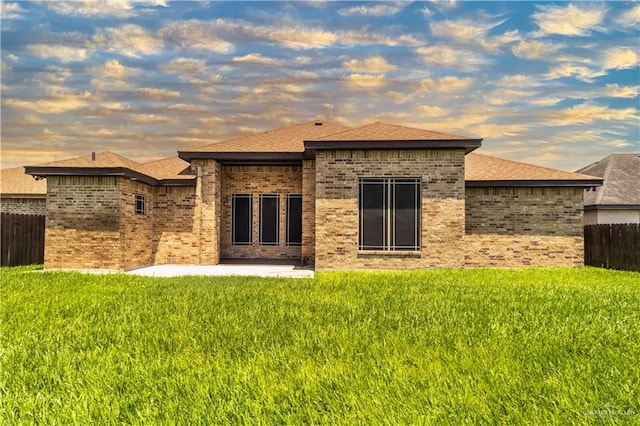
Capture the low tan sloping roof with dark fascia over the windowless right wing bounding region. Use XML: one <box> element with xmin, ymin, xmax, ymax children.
<box><xmin>465</xmin><ymin>153</ymin><xmax>602</xmax><ymax>187</ymax></box>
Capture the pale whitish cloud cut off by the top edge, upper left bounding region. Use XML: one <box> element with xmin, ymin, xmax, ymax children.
<box><xmin>45</xmin><ymin>0</ymin><xmax>167</xmax><ymax>18</ymax></box>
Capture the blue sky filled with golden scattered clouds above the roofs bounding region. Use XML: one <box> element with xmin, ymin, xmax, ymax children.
<box><xmin>1</xmin><ymin>0</ymin><xmax>640</xmax><ymax>170</ymax></box>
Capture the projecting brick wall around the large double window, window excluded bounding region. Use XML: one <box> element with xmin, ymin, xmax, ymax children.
<box><xmin>315</xmin><ymin>149</ymin><xmax>465</xmax><ymax>270</ymax></box>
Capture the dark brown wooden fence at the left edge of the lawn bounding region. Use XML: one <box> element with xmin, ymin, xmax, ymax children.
<box><xmin>0</xmin><ymin>213</ymin><xmax>45</xmax><ymax>266</ymax></box>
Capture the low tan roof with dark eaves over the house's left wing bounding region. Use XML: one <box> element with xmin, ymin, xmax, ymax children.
<box><xmin>25</xmin><ymin>152</ymin><xmax>195</xmax><ymax>186</ymax></box>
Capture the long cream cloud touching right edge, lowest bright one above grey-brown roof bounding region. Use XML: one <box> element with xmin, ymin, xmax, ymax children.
<box><xmin>542</xmin><ymin>103</ymin><xmax>638</xmax><ymax>126</ymax></box>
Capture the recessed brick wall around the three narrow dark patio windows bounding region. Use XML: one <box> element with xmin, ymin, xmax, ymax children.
<box><xmin>220</xmin><ymin>166</ymin><xmax>305</xmax><ymax>259</ymax></box>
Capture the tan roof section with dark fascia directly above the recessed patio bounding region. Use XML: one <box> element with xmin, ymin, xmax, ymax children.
<box><xmin>178</xmin><ymin>121</ymin><xmax>347</xmax><ymax>160</ymax></box>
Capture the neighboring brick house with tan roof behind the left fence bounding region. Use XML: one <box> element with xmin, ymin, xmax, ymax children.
<box><xmin>0</xmin><ymin>167</ymin><xmax>47</xmax><ymax>215</ymax></box>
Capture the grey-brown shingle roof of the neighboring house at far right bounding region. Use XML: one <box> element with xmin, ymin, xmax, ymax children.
<box><xmin>578</xmin><ymin>153</ymin><xmax>640</xmax><ymax>209</ymax></box>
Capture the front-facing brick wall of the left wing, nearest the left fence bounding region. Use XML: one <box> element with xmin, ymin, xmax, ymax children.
<box><xmin>44</xmin><ymin>176</ymin><xmax>122</xmax><ymax>269</ymax></box>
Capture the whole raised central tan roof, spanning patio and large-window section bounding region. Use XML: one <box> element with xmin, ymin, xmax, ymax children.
<box><xmin>178</xmin><ymin>121</ymin><xmax>482</xmax><ymax>161</ymax></box>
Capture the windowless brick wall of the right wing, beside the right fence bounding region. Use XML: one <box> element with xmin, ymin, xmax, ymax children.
<box><xmin>464</xmin><ymin>187</ymin><xmax>584</xmax><ymax>267</ymax></box>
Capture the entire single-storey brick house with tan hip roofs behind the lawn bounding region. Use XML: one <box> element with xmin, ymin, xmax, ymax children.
<box><xmin>26</xmin><ymin>121</ymin><xmax>602</xmax><ymax>270</ymax></box>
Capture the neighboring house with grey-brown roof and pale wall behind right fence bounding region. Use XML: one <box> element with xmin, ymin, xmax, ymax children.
<box><xmin>576</xmin><ymin>153</ymin><xmax>640</xmax><ymax>225</ymax></box>
